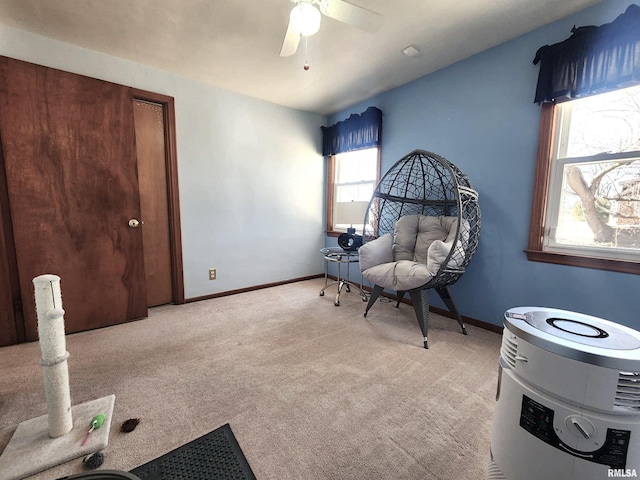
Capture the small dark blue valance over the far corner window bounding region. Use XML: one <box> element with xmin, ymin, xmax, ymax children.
<box><xmin>322</xmin><ymin>107</ymin><xmax>382</xmax><ymax>157</ymax></box>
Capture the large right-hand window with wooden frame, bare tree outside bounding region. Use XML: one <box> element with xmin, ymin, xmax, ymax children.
<box><xmin>527</xmin><ymin>86</ymin><xmax>640</xmax><ymax>273</ymax></box>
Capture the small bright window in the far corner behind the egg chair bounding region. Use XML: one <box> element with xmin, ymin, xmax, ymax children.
<box><xmin>327</xmin><ymin>147</ymin><xmax>380</xmax><ymax>235</ymax></box>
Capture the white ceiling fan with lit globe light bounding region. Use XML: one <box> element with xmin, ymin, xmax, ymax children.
<box><xmin>280</xmin><ymin>0</ymin><xmax>382</xmax><ymax>57</ymax></box>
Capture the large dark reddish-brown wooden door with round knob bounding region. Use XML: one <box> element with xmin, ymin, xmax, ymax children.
<box><xmin>0</xmin><ymin>57</ymin><xmax>147</xmax><ymax>340</ymax></box>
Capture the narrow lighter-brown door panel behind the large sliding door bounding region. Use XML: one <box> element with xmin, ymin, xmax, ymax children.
<box><xmin>133</xmin><ymin>99</ymin><xmax>173</xmax><ymax>307</ymax></box>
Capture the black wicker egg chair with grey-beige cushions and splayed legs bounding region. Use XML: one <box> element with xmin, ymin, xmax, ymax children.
<box><xmin>359</xmin><ymin>150</ymin><xmax>480</xmax><ymax>348</ymax></box>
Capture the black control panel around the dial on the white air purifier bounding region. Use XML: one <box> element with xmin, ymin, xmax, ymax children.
<box><xmin>520</xmin><ymin>395</ymin><xmax>631</xmax><ymax>468</ymax></box>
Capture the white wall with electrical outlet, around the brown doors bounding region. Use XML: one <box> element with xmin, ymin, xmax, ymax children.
<box><xmin>0</xmin><ymin>25</ymin><xmax>325</xmax><ymax>298</ymax></box>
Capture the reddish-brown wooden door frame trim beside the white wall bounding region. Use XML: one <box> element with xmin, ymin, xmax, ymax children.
<box><xmin>131</xmin><ymin>88</ymin><xmax>185</xmax><ymax>305</ymax></box>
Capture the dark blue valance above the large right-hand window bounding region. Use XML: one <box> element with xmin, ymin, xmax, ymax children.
<box><xmin>533</xmin><ymin>5</ymin><xmax>640</xmax><ymax>103</ymax></box>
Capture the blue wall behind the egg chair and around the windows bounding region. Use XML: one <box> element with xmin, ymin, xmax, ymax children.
<box><xmin>326</xmin><ymin>0</ymin><xmax>640</xmax><ymax>330</ymax></box>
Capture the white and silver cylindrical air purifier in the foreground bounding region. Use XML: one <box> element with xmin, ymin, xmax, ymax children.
<box><xmin>488</xmin><ymin>307</ymin><xmax>640</xmax><ymax>480</ymax></box>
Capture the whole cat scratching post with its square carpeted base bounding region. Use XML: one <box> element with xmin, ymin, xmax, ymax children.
<box><xmin>0</xmin><ymin>275</ymin><xmax>115</xmax><ymax>480</ymax></box>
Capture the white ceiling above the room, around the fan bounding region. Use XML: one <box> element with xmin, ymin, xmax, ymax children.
<box><xmin>0</xmin><ymin>0</ymin><xmax>601</xmax><ymax>115</ymax></box>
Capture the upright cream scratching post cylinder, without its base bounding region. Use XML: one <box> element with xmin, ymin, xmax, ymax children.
<box><xmin>33</xmin><ymin>275</ymin><xmax>73</xmax><ymax>438</ymax></box>
